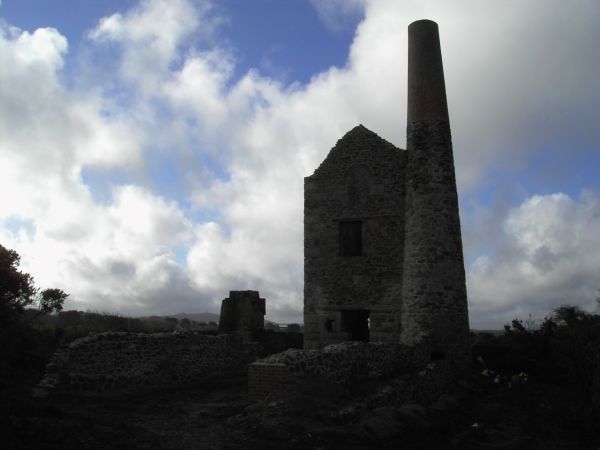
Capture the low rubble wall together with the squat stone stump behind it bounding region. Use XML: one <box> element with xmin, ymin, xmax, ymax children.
<box><xmin>38</xmin><ymin>291</ymin><xmax>284</xmax><ymax>392</ymax></box>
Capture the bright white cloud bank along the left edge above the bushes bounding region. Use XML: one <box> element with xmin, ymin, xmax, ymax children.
<box><xmin>0</xmin><ymin>21</ymin><xmax>203</xmax><ymax>314</ymax></box>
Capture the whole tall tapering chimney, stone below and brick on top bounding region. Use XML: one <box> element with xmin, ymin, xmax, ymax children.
<box><xmin>401</xmin><ymin>20</ymin><xmax>469</xmax><ymax>364</ymax></box>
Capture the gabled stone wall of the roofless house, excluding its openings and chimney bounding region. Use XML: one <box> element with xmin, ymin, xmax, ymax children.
<box><xmin>304</xmin><ymin>125</ymin><xmax>406</xmax><ymax>348</ymax></box>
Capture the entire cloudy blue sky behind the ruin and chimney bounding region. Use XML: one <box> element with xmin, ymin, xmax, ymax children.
<box><xmin>0</xmin><ymin>0</ymin><xmax>600</xmax><ymax>328</ymax></box>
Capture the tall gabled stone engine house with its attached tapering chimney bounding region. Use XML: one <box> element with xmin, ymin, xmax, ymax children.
<box><xmin>304</xmin><ymin>20</ymin><xmax>469</xmax><ymax>366</ymax></box>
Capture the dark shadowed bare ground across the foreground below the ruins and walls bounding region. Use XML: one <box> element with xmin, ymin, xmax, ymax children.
<box><xmin>0</xmin><ymin>374</ymin><xmax>600</xmax><ymax>450</ymax></box>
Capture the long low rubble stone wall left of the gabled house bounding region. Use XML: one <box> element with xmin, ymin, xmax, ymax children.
<box><xmin>39</xmin><ymin>332</ymin><xmax>260</xmax><ymax>392</ymax></box>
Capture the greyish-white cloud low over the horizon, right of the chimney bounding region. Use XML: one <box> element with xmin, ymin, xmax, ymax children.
<box><xmin>468</xmin><ymin>191</ymin><xmax>600</xmax><ymax>325</ymax></box>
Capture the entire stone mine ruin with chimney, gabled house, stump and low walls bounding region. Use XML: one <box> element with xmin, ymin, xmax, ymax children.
<box><xmin>40</xmin><ymin>20</ymin><xmax>470</xmax><ymax>400</ymax></box>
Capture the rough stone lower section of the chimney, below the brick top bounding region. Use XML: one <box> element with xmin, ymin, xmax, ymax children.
<box><xmin>402</xmin><ymin>120</ymin><xmax>469</xmax><ymax>364</ymax></box>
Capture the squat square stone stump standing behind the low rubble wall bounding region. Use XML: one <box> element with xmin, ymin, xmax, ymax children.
<box><xmin>219</xmin><ymin>291</ymin><xmax>266</xmax><ymax>341</ymax></box>
